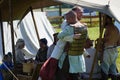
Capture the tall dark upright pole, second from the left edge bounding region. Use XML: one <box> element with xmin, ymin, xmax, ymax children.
<box><xmin>9</xmin><ymin>0</ymin><xmax>16</xmax><ymax>64</ymax></box>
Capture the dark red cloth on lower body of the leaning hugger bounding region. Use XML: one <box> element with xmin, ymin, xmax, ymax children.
<box><xmin>40</xmin><ymin>58</ymin><xmax>58</xmax><ymax>80</ymax></box>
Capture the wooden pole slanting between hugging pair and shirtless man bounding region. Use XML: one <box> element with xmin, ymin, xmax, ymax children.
<box><xmin>89</xmin><ymin>13</ymin><xmax>104</xmax><ymax>80</ymax></box>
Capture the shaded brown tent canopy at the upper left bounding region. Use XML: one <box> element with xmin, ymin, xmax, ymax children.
<box><xmin>0</xmin><ymin>0</ymin><xmax>60</xmax><ymax>21</ymax></box>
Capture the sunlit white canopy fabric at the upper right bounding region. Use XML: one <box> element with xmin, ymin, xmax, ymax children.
<box><xmin>56</xmin><ymin>0</ymin><xmax>120</xmax><ymax>22</ymax></box>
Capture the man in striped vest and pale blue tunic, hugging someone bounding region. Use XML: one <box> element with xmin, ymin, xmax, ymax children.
<box><xmin>58</xmin><ymin>6</ymin><xmax>87</xmax><ymax>80</ymax></box>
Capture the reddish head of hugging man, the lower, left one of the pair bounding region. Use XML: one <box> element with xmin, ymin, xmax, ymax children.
<box><xmin>65</xmin><ymin>11</ymin><xmax>77</xmax><ymax>24</ymax></box>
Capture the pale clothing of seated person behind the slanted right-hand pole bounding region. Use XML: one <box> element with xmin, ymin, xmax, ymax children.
<box><xmin>81</xmin><ymin>47</ymin><xmax>101</xmax><ymax>78</ymax></box>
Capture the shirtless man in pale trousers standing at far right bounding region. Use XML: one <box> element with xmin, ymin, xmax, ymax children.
<box><xmin>101</xmin><ymin>16</ymin><xmax>119</xmax><ymax>80</ymax></box>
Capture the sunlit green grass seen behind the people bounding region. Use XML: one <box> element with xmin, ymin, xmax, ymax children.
<box><xmin>55</xmin><ymin>27</ymin><xmax>120</xmax><ymax>72</ymax></box>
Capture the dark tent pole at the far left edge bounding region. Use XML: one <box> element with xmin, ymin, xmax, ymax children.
<box><xmin>0</xmin><ymin>9</ymin><xmax>5</xmax><ymax>56</ymax></box>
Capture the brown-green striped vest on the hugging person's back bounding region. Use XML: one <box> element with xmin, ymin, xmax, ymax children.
<box><xmin>68</xmin><ymin>27</ymin><xmax>87</xmax><ymax>56</ymax></box>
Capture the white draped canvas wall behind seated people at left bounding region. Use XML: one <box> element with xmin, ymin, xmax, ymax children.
<box><xmin>0</xmin><ymin>11</ymin><xmax>55</xmax><ymax>61</ymax></box>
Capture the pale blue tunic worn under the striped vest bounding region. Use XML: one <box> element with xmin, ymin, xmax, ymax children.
<box><xmin>58</xmin><ymin>23</ymin><xmax>87</xmax><ymax>73</ymax></box>
